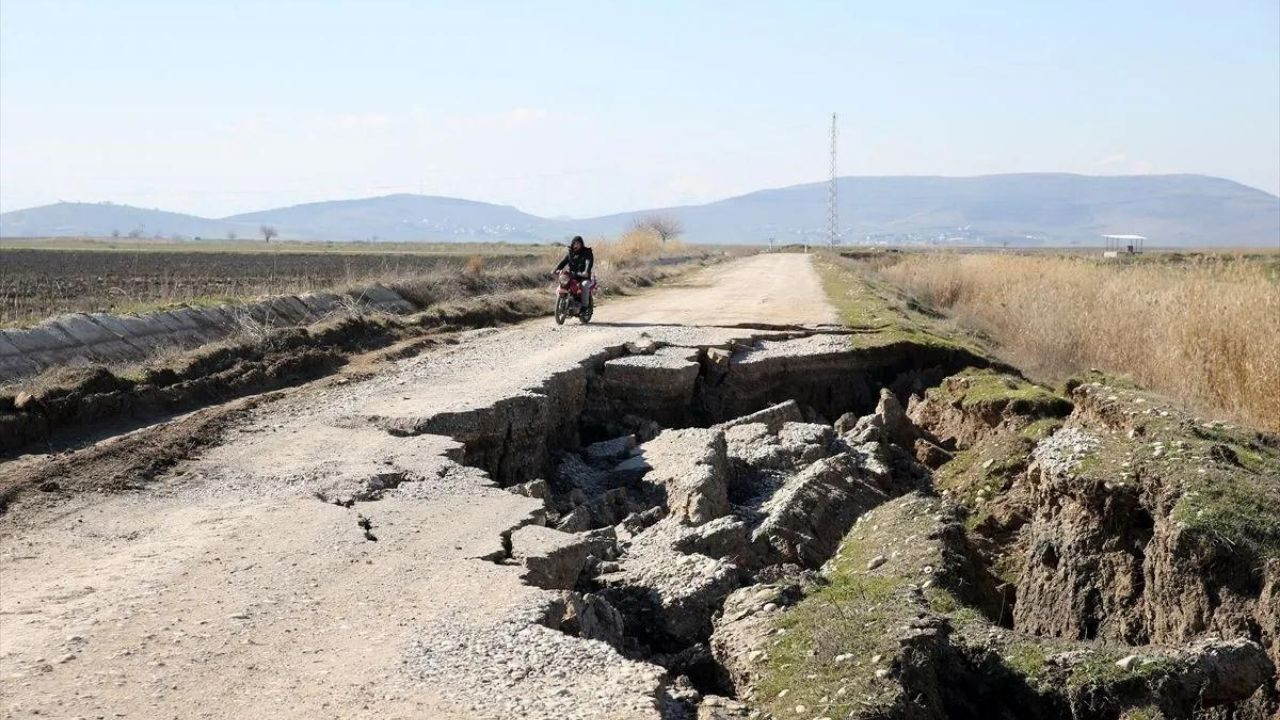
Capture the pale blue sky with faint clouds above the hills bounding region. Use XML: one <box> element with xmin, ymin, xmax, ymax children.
<box><xmin>0</xmin><ymin>0</ymin><xmax>1280</xmax><ymax>217</ymax></box>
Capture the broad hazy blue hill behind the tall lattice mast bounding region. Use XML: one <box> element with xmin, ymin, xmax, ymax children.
<box><xmin>581</xmin><ymin>173</ymin><xmax>1280</xmax><ymax>246</ymax></box>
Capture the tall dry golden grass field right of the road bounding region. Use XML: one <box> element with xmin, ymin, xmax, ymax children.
<box><xmin>878</xmin><ymin>254</ymin><xmax>1280</xmax><ymax>430</ymax></box>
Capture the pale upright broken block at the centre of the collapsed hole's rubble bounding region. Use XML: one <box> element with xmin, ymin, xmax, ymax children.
<box><xmin>640</xmin><ymin>428</ymin><xmax>728</xmax><ymax>525</ymax></box>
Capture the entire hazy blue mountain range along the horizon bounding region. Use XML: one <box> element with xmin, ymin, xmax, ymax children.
<box><xmin>0</xmin><ymin>173</ymin><xmax>1280</xmax><ymax>247</ymax></box>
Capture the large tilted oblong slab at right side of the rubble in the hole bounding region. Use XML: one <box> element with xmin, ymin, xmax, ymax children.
<box><xmin>751</xmin><ymin>452</ymin><xmax>887</xmax><ymax>568</ymax></box>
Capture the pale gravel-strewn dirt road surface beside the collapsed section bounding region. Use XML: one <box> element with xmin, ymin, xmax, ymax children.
<box><xmin>0</xmin><ymin>255</ymin><xmax>835</xmax><ymax>719</ymax></box>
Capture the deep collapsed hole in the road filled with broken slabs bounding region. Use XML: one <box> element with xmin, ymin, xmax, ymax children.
<box><xmin>343</xmin><ymin>328</ymin><xmax>998</xmax><ymax>717</ymax></box>
